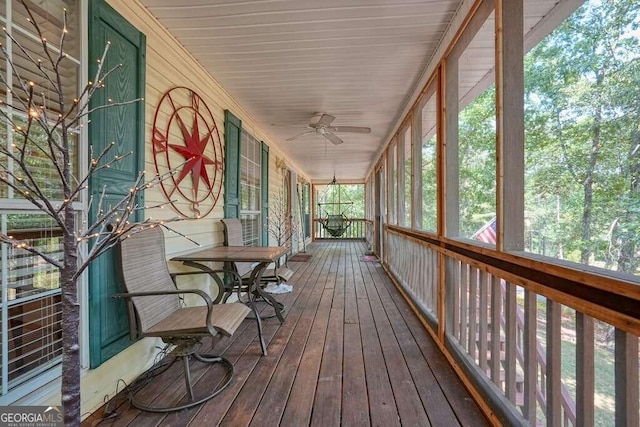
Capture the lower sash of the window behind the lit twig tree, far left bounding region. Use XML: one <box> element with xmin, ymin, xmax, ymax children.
<box><xmin>0</xmin><ymin>214</ymin><xmax>62</xmax><ymax>396</ymax></box>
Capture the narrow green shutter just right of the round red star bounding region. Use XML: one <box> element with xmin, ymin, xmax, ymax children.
<box><xmin>224</xmin><ymin>110</ymin><xmax>242</xmax><ymax>218</ymax></box>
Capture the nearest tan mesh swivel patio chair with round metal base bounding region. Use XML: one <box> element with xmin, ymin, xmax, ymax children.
<box><xmin>113</xmin><ymin>227</ymin><xmax>250</xmax><ymax>412</ymax></box>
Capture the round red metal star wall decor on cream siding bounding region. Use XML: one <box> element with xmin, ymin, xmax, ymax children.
<box><xmin>152</xmin><ymin>87</ymin><xmax>223</xmax><ymax>218</ymax></box>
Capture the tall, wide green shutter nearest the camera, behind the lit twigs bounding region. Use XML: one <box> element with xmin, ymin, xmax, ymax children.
<box><xmin>89</xmin><ymin>0</ymin><xmax>146</xmax><ymax>368</ymax></box>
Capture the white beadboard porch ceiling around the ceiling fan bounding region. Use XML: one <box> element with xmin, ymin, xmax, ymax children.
<box><xmin>140</xmin><ymin>0</ymin><xmax>558</xmax><ymax>181</ymax></box>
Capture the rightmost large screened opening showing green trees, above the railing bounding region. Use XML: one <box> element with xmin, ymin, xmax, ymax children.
<box><xmin>525</xmin><ymin>0</ymin><xmax>640</xmax><ymax>275</ymax></box>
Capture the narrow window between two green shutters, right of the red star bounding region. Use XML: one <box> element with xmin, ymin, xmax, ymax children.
<box><xmin>240</xmin><ymin>129</ymin><xmax>262</xmax><ymax>246</ymax></box>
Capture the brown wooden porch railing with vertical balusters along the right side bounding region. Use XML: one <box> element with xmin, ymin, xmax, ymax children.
<box><xmin>383</xmin><ymin>226</ymin><xmax>640</xmax><ymax>426</ymax></box>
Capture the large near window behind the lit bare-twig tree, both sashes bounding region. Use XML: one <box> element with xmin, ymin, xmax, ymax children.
<box><xmin>0</xmin><ymin>0</ymin><xmax>81</xmax><ymax>404</ymax></box>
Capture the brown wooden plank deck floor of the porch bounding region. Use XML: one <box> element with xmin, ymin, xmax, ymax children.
<box><xmin>83</xmin><ymin>241</ymin><xmax>487</xmax><ymax>427</ymax></box>
